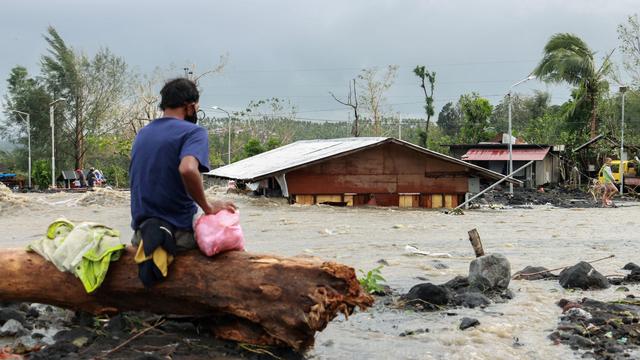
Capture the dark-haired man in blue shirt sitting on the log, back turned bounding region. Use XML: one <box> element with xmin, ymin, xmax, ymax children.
<box><xmin>129</xmin><ymin>78</ymin><xmax>235</xmax><ymax>255</ymax></box>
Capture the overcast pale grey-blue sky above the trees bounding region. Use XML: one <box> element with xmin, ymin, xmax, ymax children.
<box><xmin>0</xmin><ymin>0</ymin><xmax>640</xmax><ymax>124</ymax></box>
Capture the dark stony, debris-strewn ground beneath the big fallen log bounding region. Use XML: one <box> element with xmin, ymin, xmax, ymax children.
<box><xmin>0</xmin><ymin>303</ymin><xmax>301</xmax><ymax>360</ymax></box>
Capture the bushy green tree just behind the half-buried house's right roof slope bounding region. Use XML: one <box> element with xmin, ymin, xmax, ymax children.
<box><xmin>459</xmin><ymin>93</ymin><xmax>493</xmax><ymax>144</ymax></box>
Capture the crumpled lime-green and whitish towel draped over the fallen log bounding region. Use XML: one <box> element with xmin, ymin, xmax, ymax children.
<box><xmin>27</xmin><ymin>219</ymin><xmax>125</xmax><ymax>293</ymax></box>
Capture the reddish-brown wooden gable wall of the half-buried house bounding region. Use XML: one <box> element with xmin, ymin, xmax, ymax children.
<box><xmin>286</xmin><ymin>143</ymin><xmax>469</xmax><ymax>206</ymax></box>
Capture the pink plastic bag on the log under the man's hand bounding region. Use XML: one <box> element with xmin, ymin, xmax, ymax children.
<box><xmin>195</xmin><ymin>210</ymin><xmax>244</xmax><ymax>256</ymax></box>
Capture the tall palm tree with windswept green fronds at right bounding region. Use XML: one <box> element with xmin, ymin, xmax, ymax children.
<box><xmin>533</xmin><ymin>33</ymin><xmax>613</xmax><ymax>138</ymax></box>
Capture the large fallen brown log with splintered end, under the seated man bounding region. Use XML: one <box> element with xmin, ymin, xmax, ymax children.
<box><xmin>0</xmin><ymin>248</ymin><xmax>373</xmax><ymax>351</ymax></box>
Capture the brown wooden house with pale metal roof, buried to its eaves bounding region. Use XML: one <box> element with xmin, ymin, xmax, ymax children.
<box><xmin>206</xmin><ymin>137</ymin><xmax>521</xmax><ymax>208</ymax></box>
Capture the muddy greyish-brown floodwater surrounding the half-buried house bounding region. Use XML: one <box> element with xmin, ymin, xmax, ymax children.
<box><xmin>0</xmin><ymin>190</ymin><xmax>640</xmax><ymax>359</ymax></box>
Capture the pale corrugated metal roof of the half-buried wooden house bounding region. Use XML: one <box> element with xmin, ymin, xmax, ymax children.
<box><xmin>206</xmin><ymin>137</ymin><xmax>521</xmax><ymax>184</ymax></box>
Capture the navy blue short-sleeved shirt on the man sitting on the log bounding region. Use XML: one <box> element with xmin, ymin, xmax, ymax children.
<box><xmin>129</xmin><ymin>118</ymin><xmax>209</xmax><ymax>230</ymax></box>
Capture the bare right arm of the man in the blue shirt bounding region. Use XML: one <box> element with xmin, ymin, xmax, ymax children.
<box><xmin>178</xmin><ymin>155</ymin><xmax>236</xmax><ymax>215</ymax></box>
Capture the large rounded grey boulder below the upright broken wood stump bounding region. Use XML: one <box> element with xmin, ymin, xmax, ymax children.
<box><xmin>469</xmin><ymin>254</ymin><xmax>511</xmax><ymax>292</ymax></box>
